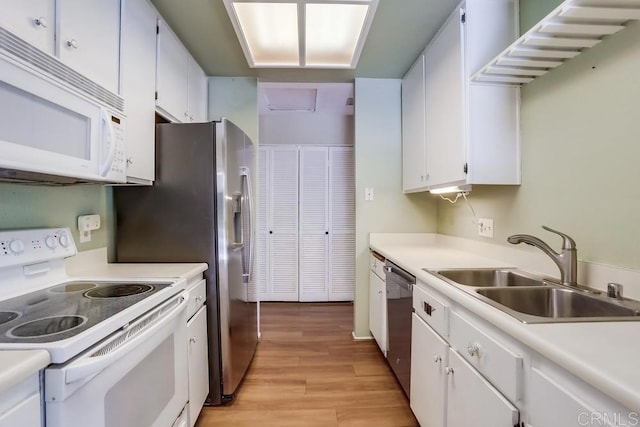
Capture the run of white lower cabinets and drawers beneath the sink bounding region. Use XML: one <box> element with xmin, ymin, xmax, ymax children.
<box><xmin>410</xmin><ymin>281</ymin><xmax>640</xmax><ymax>427</ymax></box>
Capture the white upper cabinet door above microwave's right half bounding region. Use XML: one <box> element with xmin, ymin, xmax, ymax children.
<box><xmin>56</xmin><ymin>0</ymin><xmax>120</xmax><ymax>93</ymax></box>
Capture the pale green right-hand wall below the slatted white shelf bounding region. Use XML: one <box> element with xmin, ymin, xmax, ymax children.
<box><xmin>438</xmin><ymin>14</ymin><xmax>640</xmax><ymax>269</ymax></box>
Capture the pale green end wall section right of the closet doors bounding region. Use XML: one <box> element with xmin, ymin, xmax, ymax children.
<box><xmin>354</xmin><ymin>79</ymin><xmax>436</xmax><ymax>337</ymax></box>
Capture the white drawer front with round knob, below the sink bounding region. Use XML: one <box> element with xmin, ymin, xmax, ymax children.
<box><xmin>449</xmin><ymin>313</ymin><xmax>523</xmax><ymax>402</ymax></box>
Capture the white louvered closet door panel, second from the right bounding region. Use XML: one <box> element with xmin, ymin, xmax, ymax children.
<box><xmin>300</xmin><ymin>147</ymin><xmax>329</xmax><ymax>302</ymax></box>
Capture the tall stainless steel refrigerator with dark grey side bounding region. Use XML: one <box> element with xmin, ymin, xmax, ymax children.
<box><xmin>114</xmin><ymin>119</ymin><xmax>258</xmax><ymax>405</ymax></box>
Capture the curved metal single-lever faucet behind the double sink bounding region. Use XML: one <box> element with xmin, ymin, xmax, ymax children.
<box><xmin>507</xmin><ymin>225</ymin><xmax>578</xmax><ymax>286</ymax></box>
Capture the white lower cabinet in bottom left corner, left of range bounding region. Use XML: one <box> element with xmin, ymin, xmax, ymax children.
<box><xmin>0</xmin><ymin>373</ymin><xmax>42</xmax><ymax>427</ymax></box>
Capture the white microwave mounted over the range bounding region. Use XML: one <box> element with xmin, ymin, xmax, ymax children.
<box><xmin>0</xmin><ymin>28</ymin><xmax>126</xmax><ymax>184</ymax></box>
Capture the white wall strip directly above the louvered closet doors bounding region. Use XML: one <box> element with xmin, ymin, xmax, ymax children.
<box><xmin>260</xmin><ymin>112</ymin><xmax>354</xmax><ymax>146</ymax></box>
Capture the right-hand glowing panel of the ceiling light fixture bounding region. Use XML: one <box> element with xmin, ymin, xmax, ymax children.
<box><xmin>305</xmin><ymin>3</ymin><xmax>370</xmax><ymax>67</ymax></box>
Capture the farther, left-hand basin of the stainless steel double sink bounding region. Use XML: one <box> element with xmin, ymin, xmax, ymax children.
<box><xmin>431</xmin><ymin>268</ymin><xmax>545</xmax><ymax>288</ymax></box>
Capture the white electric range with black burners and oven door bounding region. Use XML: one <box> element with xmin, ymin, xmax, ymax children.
<box><xmin>0</xmin><ymin>228</ymin><xmax>188</xmax><ymax>427</ymax></box>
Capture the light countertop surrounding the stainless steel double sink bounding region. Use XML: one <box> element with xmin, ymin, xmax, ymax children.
<box><xmin>370</xmin><ymin>234</ymin><xmax>640</xmax><ymax>412</ymax></box>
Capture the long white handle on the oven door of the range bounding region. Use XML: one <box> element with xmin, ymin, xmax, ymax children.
<box><xmin>65</xmin><ymin>291</ymin><xmax>189</xmax><ymax>384</ymax></box>
